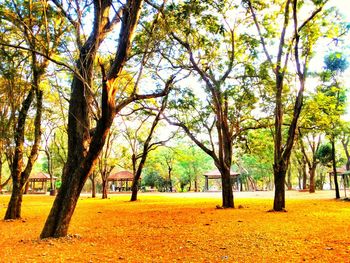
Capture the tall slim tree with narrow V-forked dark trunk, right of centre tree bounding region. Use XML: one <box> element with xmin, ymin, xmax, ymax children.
<box><xmin>245</xmin><ymin>0</ymin><xmax>332</xmax><ymax>211</ymax></box>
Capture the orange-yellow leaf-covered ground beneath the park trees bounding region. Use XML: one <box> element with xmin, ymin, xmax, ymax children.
<box><xmin>0</xmin><ymin>191</ymin><xmax>350</xmax><ymax>262</ymax></box>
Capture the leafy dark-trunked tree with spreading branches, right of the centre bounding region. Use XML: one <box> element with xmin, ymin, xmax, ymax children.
<box><xmin>155</xmin><ymin>1</ymin><xmax>256</xmax><ymax>208</ymax></box>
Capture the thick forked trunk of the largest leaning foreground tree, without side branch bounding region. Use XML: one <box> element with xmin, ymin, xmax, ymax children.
<box><xmin>40</xmin><ymin>0</ymin><xmax>143</xmax><ymax>238</ymax></box>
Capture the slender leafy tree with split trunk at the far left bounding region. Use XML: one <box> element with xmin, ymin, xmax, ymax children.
<box><xmin>0</xmin><ymin>1</ymin><xmax>64</xmax><ymax>219</ymax></box>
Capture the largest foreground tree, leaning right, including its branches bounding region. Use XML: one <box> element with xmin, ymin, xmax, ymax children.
<box><xmin>41</xmin><ymin>0</ymin><xmax>173</xmax><ymax>238</ymax></box>
